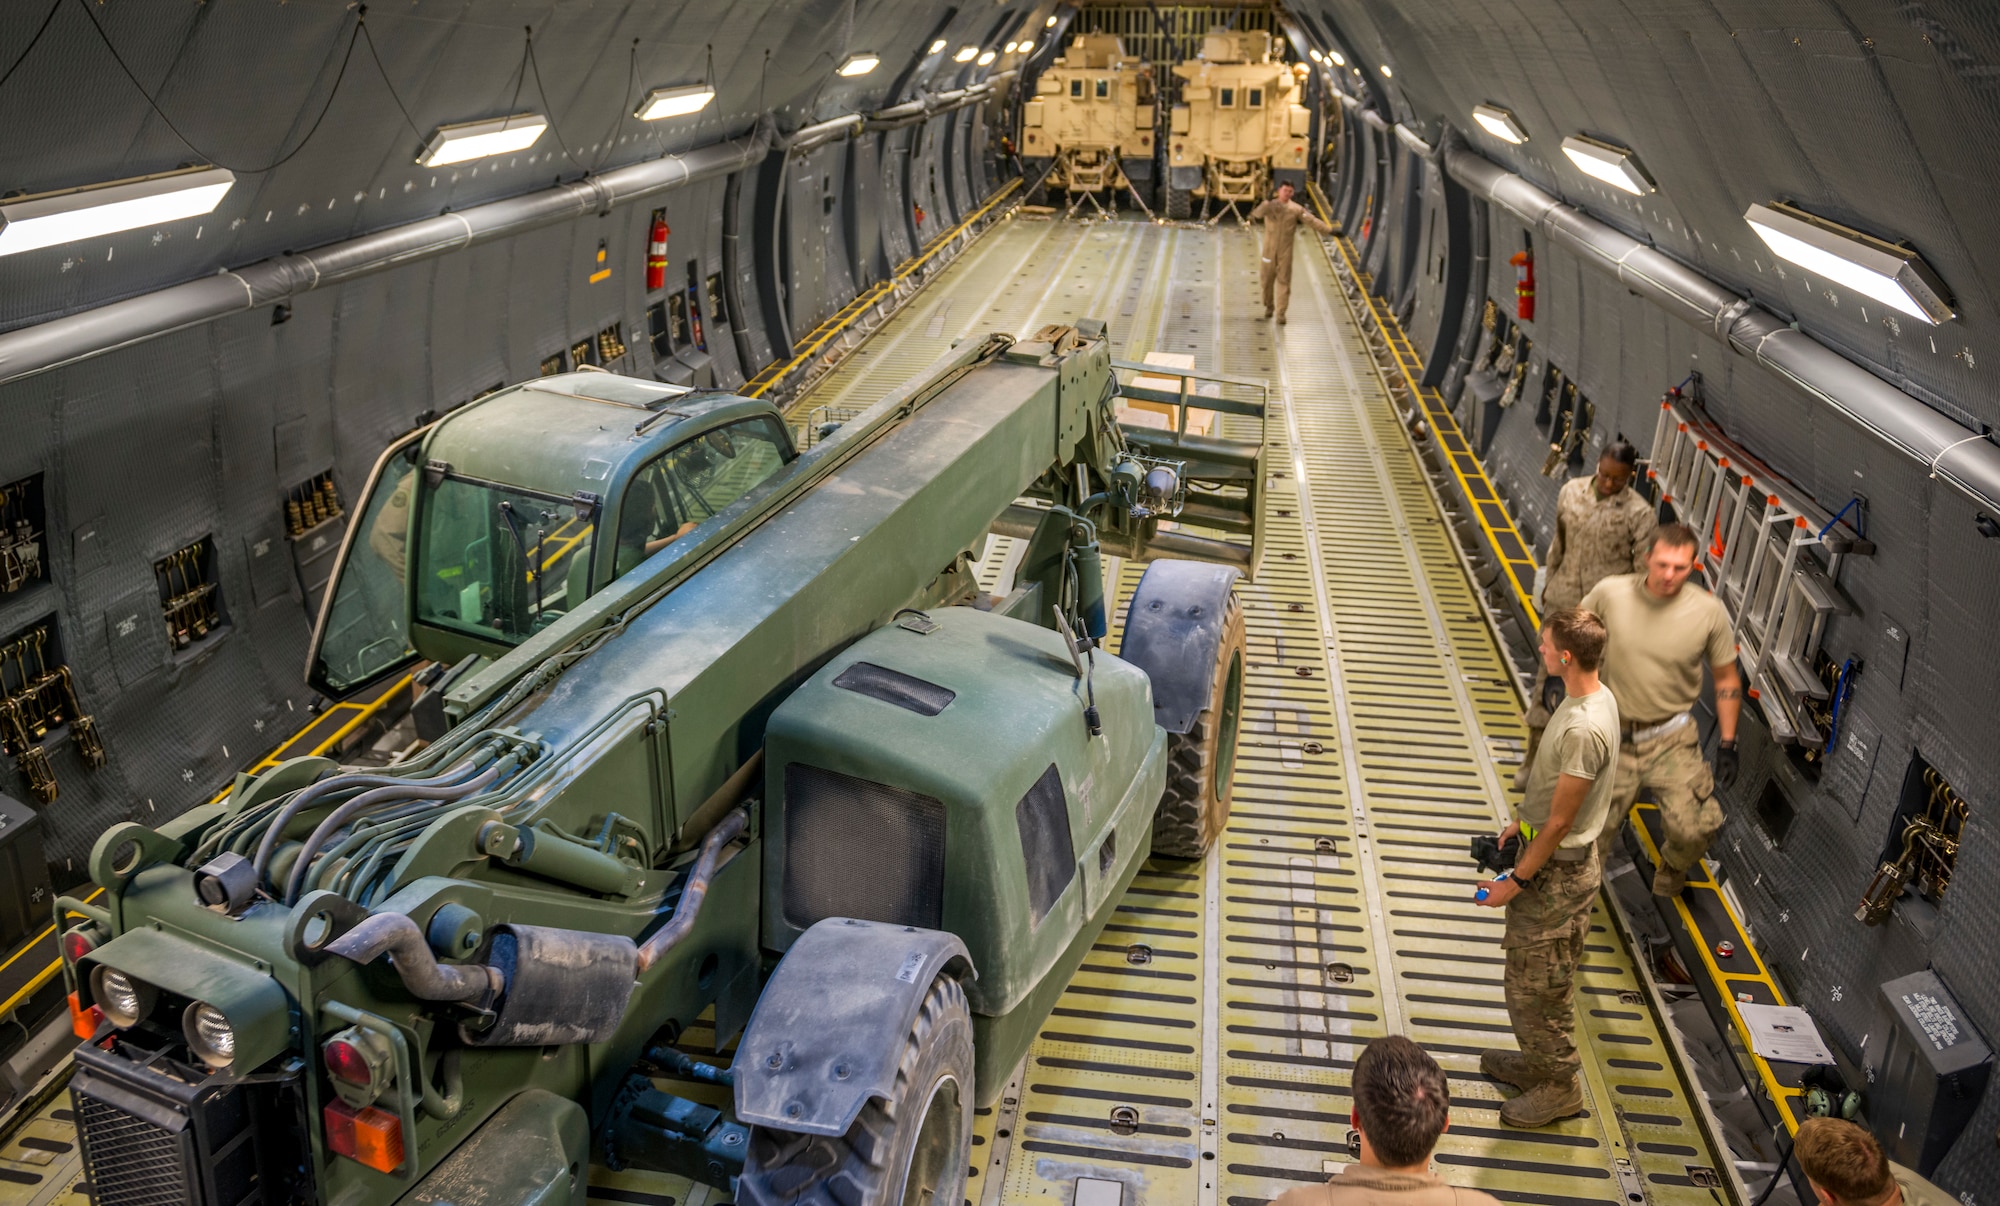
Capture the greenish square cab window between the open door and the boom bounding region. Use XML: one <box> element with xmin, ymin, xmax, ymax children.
<box><xmin>416</xmin><ymin>474</ymin><xmax>596</xmax><ymax>644</ymax></box>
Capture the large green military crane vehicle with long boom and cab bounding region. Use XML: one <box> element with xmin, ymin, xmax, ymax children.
<box><xmin>58</xmin><ymin>324</ymin><xmax>1264</xmax><ymax>1206</ymax></box>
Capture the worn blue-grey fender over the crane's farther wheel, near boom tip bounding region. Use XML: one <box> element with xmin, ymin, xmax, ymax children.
<box><xmin>1118</xmin><ymin>560</ymin><xmax>1242</xmax><ymax>734</ymax></box>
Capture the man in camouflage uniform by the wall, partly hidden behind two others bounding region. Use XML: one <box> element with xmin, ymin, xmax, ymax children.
<box><xmin>1514</xmin><ymin>440</ymin><xmax>1660</xmax><ymax>790</ymax></box>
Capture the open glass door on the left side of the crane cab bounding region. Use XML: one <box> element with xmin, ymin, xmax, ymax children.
<box><xmin>306</xmin><ymin>426</ymin><xmax>430</xmax><ymax>700</ymax></box>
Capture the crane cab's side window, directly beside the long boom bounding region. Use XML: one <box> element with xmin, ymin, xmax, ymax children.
<box><xmin>614</xmin><ymin>418</ymin><xmax>792</xmax><ymax>574</ymax></box>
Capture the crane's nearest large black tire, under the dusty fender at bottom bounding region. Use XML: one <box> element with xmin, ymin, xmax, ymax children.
<box><xmin>736</xmin><ymin>976</ymin><xmax>972</xmax><ymax>1206</ymax></box>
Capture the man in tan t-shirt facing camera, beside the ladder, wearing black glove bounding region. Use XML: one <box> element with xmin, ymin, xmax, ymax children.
<box><xmin>1582</xmin><ymin>524</ymin><xmax>1744</xmax><ymax>896</ymax></box>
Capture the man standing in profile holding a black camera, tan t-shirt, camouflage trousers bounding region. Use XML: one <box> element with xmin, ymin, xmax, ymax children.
<box><xmin>1474</xmin><ymin>608</ymin><xmax>1618</xmax><ymax>1126</ymax></box>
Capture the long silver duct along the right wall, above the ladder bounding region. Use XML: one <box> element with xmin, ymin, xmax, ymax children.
<box><xmin>1444</xmin><ymin>144</ymin><xmax>2000</xmax><ymax>510</ymax></box>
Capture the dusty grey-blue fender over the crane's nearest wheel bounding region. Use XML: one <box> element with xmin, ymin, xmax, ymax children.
<box><xmin>732</xmin><ymin>918</ymin><xmax>976</xmax><ymax>1136</ymax></box>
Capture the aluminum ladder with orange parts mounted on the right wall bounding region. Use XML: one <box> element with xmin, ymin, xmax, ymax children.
<box><xmin>1646</xmin><ymin>382</ymin><xmax>1874</xmax><ymax>748</ymax></box>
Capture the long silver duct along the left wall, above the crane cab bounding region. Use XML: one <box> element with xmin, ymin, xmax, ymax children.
<box><xmin>0</xmin><ymin>120</ymin><xmax>772</xmax><ymax>384</ymax></box>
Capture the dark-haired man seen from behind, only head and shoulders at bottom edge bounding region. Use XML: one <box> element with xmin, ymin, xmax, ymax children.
<box><xmin>1272</xmin><ymin>1034</ymin><xmax>1500</xmax><ymax>1206</ymax></box>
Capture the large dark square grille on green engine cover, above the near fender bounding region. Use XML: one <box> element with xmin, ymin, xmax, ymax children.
<box><xmin>784</xmin><ymin>762</ymin><xmax>944</xmax><ymax>930</ymax></box>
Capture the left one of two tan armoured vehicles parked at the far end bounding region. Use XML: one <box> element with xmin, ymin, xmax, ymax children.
<box><xmin>1020</xmin><ymin>34</ymin><xmax>1154</xmax><ymax>208</ymax></box>
